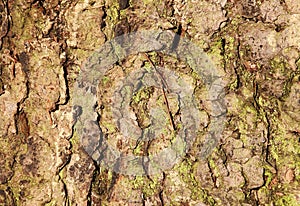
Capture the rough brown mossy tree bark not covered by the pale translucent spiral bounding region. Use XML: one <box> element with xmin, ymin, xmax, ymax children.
<box><xmin>0</xmin><ymin>0</ymin><xmax>300</xmax><ymax>206</ymax></box>
